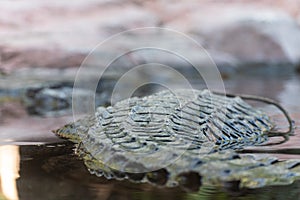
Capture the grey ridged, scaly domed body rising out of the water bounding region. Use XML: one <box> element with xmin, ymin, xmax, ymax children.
<box><xmin>55</xmin><ymin>90</ymin><xmax>292</xmax><ymax>186</ymax></box>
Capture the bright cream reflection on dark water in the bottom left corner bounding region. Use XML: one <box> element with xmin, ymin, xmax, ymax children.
<box><xmin>0</xmin><ymin>145</ymin><xmax>20</xmax><ymax>200</ymax></box>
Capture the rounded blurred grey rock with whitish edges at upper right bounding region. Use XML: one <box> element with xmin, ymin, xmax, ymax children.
<box><xmin>211</xmin><ymin>11</ymin><xmax>300</xmax><ymax>65</ymax></box>
